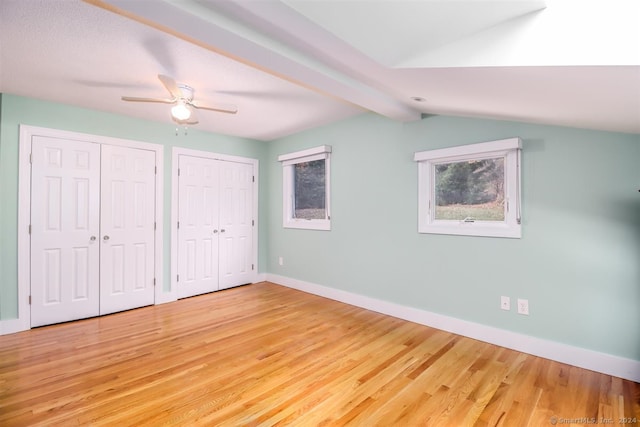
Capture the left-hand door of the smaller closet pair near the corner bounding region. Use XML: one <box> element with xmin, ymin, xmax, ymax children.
<box><xmin>177</xmin><ymin>155</ymin><xmax>220</xmax><ymax>298</ymax></box>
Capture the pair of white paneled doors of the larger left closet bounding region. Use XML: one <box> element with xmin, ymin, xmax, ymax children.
<box><xmin>31</xmin><ymin>136</ymin><xmax>155</xmax><ymax>327</ymax></box>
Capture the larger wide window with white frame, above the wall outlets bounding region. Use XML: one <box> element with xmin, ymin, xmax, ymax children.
<box><xmin>414</xmin><ymin>138</ymin><xmax>522</xmax><ymax>238</ymax></box>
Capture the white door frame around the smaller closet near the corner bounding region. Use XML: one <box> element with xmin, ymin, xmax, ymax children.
<box><xmin>169</xmin><ymin>147</ymin><xmax>260</xmax><ymax>300</ymax></box>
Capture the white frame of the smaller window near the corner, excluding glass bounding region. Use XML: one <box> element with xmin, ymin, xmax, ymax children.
<box><xmin>278</xmin><ymin>145</ymin><xmax>331</xmax><ymax>230</ymax></box>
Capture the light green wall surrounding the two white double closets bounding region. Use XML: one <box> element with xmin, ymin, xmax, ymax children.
<box><xmin>0</xmin><ymin>94</ymin><xmax>268</xmax><ymax>319</ymax></box>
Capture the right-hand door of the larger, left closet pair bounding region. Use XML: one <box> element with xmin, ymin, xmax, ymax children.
<box><xmin>100</xmin><ymin>145</ymin><xmax>155</xmax><ymax>314</ymax></box>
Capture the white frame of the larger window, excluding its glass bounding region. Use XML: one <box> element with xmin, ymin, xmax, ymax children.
<box><xmin>414</xmin><ymin>138</ymin><xmax>522</xmax><ymax>239</ymax></box>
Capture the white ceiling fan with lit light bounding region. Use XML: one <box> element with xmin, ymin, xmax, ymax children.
<box><xmin>122</xmin><ymin>74</ymin><xmax>238</xmax><ymax>125</ymax></box>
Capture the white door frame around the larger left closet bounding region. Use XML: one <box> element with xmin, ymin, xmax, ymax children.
<box><xmin>16</xmin><ymin>124</ymin><xmax>165</xmax><ymax>332</ymax></box>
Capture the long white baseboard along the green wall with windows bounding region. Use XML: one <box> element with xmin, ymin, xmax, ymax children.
<box><xmin>266</xmin><ymin>273</ymin><xmax>640</xmax><ymax>382</ymax></box>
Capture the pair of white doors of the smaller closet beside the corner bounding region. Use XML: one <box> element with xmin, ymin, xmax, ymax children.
<box><xmin>177</xmin><ymin>155</ymin><xmax>254</xmax><ymax>298</ymax></box>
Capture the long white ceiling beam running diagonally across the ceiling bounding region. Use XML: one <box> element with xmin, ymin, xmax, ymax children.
<box><xmin>85</xmin><ymin>0</ymin><xmax>420</xmax><ymax>122</ymax></box>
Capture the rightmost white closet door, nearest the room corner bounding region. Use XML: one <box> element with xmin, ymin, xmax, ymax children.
<box><xmin>219</xmin><ymin>161</ymin><xmax>253</xmax><ymax>289</ymax></box>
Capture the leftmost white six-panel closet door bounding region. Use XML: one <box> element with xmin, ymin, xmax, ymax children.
<box><xmin>31</xmin><ymin>136</ymin><xmax>100</xmax><ymax>327</ymax></box>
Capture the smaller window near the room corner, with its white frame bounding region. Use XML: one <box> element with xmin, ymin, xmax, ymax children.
<box><xmin>278</xmin><ymin>145</ymin><xmax>331</xmax><ymax>230</ymax></box>
